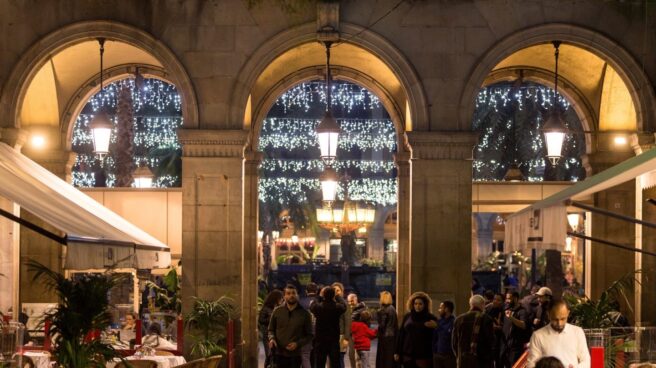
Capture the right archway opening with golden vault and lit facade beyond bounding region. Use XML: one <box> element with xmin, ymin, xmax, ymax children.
<box><xmin>463</xmin><ymin>35</ymin><xmax>653</xmax><ymax>302</ymax></box>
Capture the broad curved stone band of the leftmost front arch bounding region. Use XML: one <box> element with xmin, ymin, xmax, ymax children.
<box><xmin>0</xmin><ymin>20</ymin><xmax>198</xmax><ymax>135</ymax></box>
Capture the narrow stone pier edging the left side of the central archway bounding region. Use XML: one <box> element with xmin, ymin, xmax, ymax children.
<box><xmin>241</xmin><ymin>151</ymin><xmax>266</xmax><ymax>367</ymax></box>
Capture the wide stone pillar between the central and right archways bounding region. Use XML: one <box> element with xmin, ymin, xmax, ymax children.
<box><xmin>406</xmin><ymin>132</ymin><xmax>477</xmax><ymax>312</ymax></box>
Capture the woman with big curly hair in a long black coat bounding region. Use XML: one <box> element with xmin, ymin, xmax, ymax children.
<box><xmin>394</xmin><ymin>291</ymin><xmax>437</xmax><ymax>368</ymax></box>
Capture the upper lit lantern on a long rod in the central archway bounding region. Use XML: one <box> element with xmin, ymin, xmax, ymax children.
<box><xmin>316</xmin><ymin>42</ymin><xmax>339</xmax><ymax>167</ymax></box>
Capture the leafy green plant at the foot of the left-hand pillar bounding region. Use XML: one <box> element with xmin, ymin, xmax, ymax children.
<box><xmin>185</xmin><ymin>296</ymin><xmax>239</xmax><ymax>358</ymax></box>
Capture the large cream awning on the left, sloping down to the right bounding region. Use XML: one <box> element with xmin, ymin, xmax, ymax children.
<box><xmin>0</xmin><ymin>143</ymin><xmax>171</xmax><ymax>270</ymax></box>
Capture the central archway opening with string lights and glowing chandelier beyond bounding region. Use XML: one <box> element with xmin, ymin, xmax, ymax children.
<box><xmin>258</xmin><ymin>80</ymin><xmax>398</xmax><ymax>363</ymax></box>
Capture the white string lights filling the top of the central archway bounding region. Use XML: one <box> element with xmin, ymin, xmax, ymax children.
<box><xmin>258</xmin><ymin>82</ymin><xmax>396</xmax><ymax>212</ymax></box>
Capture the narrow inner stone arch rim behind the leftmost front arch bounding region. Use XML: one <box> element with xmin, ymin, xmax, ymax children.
<box><xmin>60</xmin><ymin>64</ymin><xmax>175</xmax><ymax>150</ymax></box>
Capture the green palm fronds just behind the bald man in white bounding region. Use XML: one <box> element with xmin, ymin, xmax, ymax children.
<box><xmin>563</xmin><ymin>271</ymin><xmax>641</xmax><ymax>329</ymax></box>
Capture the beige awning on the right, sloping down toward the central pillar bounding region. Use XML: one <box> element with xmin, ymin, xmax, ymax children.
<box><xmin>506</xmin><ymin>149</ymin><xmax>656</xmax><ymax>251</ymax></box>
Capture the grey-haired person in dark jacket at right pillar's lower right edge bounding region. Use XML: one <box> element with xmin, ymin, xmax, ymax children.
<box><xmin>451</xmin><ymin>295</ymin><xmax>494</xmax><ymax>368</ymax></box>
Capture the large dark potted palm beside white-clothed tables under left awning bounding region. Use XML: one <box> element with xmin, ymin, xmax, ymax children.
<box><xmin>27</xmin><ymin>261</ymin><xmax>126</xmax><ymax>368</ymax></box>
